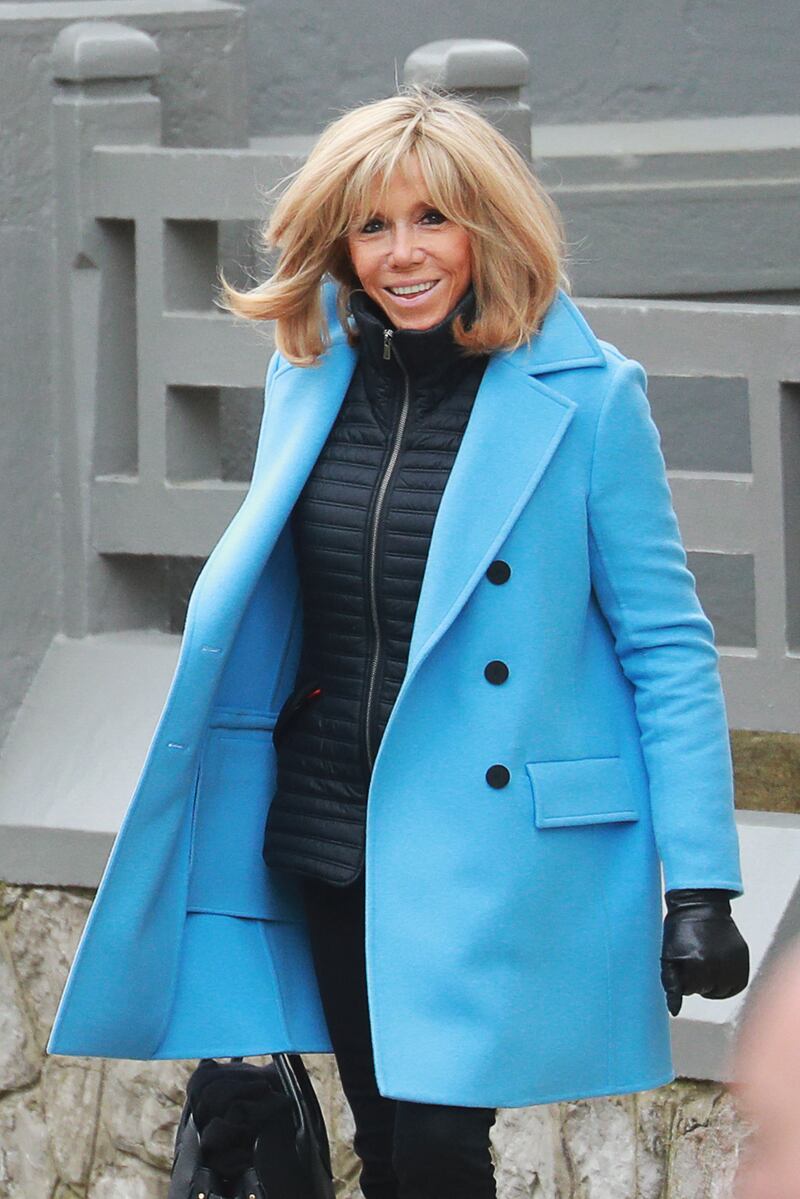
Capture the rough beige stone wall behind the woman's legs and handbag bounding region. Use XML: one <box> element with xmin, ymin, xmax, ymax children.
<box><xmin>0</xmin><ymin>885</ymin><xmax>746</xmax><ymax>1199</ymax></box>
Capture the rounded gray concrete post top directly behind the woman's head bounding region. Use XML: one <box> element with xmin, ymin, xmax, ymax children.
<box><xmin>403</xmin><ymin>37</ymin><xmax>531</xmax><ymax>162</ymax></box>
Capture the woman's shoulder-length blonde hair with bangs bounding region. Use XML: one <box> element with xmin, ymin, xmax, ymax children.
<box><xmin>217</xmin><ymin>84</ymin><xmax>569</xmax><ymax>366</ymax></box>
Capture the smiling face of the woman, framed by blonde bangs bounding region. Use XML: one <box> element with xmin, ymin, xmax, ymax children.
<box><xmin>347</xmin><ymin>158</ymin><xmax>471</xmax><ymax>329</ymax></box>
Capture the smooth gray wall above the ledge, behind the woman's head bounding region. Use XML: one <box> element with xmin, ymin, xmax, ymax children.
<box><xmin>239</xmin><ymin>0</ymin><xmax>800</xmax><ymax>133</ymax></box>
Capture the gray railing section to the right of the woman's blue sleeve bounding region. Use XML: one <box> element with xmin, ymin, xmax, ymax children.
<box><xmin>582</xmin><ymin>300</ymin><xmax>800</xmax><ymax>731</ymax></box>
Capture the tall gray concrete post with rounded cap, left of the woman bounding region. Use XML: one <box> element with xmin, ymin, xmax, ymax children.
<box><xmin>53</xmin><ymin>20</ymin><xmax>161</xmax><ymax>637</ymax></box>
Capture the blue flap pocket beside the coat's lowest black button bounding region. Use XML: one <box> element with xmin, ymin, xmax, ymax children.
<box><xmin>525</xmin><ymin>758</ymin><xmax>639</xmax><ymax>829</ymax></box>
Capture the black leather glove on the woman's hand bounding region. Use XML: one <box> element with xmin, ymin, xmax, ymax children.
<box><xmin>661</xmin><ymin>887</ymin><xmax>750</xmax><ymax>1016</ymax></box>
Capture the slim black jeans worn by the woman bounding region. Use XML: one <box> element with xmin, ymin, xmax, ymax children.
<box><xmin>303</xmin><ymin>872</ymin><xmax>497</xmax><ymax>1199</ymax></box>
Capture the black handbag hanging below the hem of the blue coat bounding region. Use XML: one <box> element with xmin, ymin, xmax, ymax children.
<box><xmin>168</xmin><ymin>1053</ymin><xmax>335</xmax><ymax>1199</ymax></box>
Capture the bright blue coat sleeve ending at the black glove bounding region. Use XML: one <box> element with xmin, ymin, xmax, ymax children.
<box><xmin>588</xmin><ymin>359</ymin><xmax>744</xmax><ymax>894</ymax></box>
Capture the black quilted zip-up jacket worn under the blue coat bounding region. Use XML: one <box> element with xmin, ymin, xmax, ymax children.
<box><xmin>264</xmin><ymin>288</ymin><xmax>488</xmax><ymax>885</ymax></box>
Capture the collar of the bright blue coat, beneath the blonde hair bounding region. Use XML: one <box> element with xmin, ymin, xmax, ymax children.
<box><xmin>323</xmin><ymin>278</ymin><xmax>606</xmax><ymax>375</ymax></box>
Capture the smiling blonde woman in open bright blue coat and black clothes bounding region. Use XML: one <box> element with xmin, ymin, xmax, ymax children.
<box><xmin>49</xmin><ymin>86</ymin><xmax>747</xmax><ymax>1199</ymax></box>
